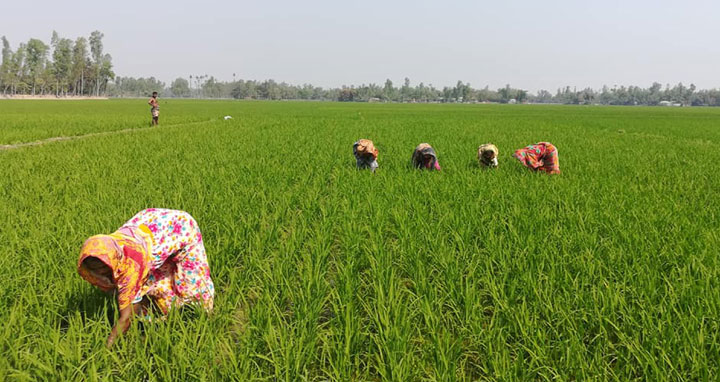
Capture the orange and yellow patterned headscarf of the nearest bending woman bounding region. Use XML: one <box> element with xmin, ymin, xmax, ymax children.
<box><xmin>77</xmin><ymin>227</ymin><xmax>153</xmax><ymax>309</ymax></box>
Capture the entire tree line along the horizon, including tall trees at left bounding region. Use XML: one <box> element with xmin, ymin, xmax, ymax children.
<box><xmin>0</xmin><ymin>31</ymin><xmax>720</xmax><ymax>106</ymax></box>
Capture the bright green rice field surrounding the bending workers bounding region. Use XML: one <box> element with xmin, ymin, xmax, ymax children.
<box><xmin>0</xmin><ymin>100</ymin><xmax>720</xmax><ymax>381</ymax></box>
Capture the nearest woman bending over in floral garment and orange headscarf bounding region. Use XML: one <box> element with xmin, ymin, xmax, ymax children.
<box><xmin>77</xmin><ymin>208</ymin><xmax>215</xmax><ymax>346</ymax></box>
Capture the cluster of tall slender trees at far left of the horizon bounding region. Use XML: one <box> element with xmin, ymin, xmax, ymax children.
<box><xmin>0</xmin><ymin>31</ymin><xmax>115</xmax><ymax>96</ymax></box>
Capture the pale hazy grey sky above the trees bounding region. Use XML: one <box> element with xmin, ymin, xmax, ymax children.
<box><xmin>0</xmin><ymin>0</ymin><xmax>720</xmax><ymax>92</ymax></box>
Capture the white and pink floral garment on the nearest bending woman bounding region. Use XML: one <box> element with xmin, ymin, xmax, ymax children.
<box><xmin>124</xmin><ymin>208</ymin><xmax>215</xmax><ymax>313</ymax></box>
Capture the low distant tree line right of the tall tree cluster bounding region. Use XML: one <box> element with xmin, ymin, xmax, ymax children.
<box><xmin>108</xmin><ymin>75</ymin><xmax>720</xmax><ymax>106</ymax></box>
